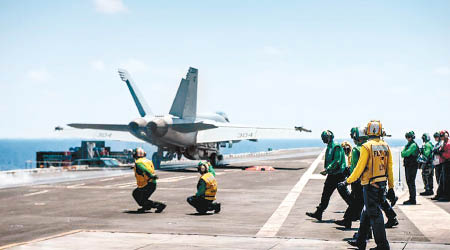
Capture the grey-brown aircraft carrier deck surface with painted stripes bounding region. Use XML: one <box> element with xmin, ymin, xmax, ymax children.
<box><xmin>0</xmin><ymin>148</ymin><xmax>450</xmax><ymax>249</ymax></box>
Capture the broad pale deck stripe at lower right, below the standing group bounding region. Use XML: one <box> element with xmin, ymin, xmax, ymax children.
<box><xmin>397</xmin><ymin>184</ymin><xmax>450</xmax><ymax>243</ymax></box>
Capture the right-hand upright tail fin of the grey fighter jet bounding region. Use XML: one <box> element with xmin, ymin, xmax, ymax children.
<box><xmin>169</xmin><ymin>68</ymin><xmax>198</xmax><ymax>118</ymax></box>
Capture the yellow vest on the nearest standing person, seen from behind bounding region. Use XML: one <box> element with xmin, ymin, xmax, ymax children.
<box><xmin>361</xmin><ymin>140</ymin><xmax>390</xmax><ymax>185</ymax></box>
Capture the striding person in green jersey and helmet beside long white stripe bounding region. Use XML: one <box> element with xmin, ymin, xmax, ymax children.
<box><xmin>306</xmin><ymin>130</ymin><xmax>348</xmax><ymax>221</ymax></box>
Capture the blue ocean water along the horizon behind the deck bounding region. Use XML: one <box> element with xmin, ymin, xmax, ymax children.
<box><xmin>0</xmin><ymin>139</ymin><xmax>406</xmax><ymax>171</ymax></box>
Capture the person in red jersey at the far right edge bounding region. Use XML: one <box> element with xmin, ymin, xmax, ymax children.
<box><xmin>438</xmin><ymin>130</ymin><xmax>450</xmax><ymax>202</ymax></box>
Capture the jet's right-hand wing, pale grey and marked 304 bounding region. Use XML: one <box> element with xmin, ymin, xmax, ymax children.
<box><xmin>197</xmin><ymin>123</ymin><xmax>310</xmax><ymax>143</ymax></box>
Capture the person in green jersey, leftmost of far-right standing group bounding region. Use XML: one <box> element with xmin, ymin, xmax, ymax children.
<box><xmin>401</xmin><ymin>131</ymin><xmax>419</xmax><ymax>205</ymax></box>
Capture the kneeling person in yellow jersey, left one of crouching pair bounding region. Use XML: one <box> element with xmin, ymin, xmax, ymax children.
<box><xmin>133</xmin><ymin>148</ymin><xmax>166</xmax><ymax>213</ymax></box>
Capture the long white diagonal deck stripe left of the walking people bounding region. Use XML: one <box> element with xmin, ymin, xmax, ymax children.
<box><xmin>256</xmin><ymin>150</ymin><xmax>325</xmax><ymax>237</ymax></box>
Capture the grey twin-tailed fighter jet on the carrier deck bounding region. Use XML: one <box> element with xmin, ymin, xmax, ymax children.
<box><xmin>68</xmin><ymin>68</ymin><xmax>309</xmax><ymax>168</ymax></box>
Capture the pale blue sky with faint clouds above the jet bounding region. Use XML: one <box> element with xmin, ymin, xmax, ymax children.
<box><xmin>0</xmin><ymin>0</ymin><xmax>450</xmax><ymax>138</ymax></box>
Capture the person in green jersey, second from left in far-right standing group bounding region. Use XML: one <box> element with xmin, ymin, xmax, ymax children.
<box><xmin>417</xmin><ymin>133</ymin><xmax>434</xmax><ymax>196</ymax></box>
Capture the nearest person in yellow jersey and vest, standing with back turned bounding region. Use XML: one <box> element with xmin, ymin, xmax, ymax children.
<box><xmin>339</xmin><ymin>120</ymin><xmax>394</xmax><ymax>250</ymax></box>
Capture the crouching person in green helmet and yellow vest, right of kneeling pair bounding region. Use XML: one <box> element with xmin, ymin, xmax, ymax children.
<box><xmin>187</xmin><ymin>162</ymin><xmax>220</xmax><ymax>214</ymax></box>
